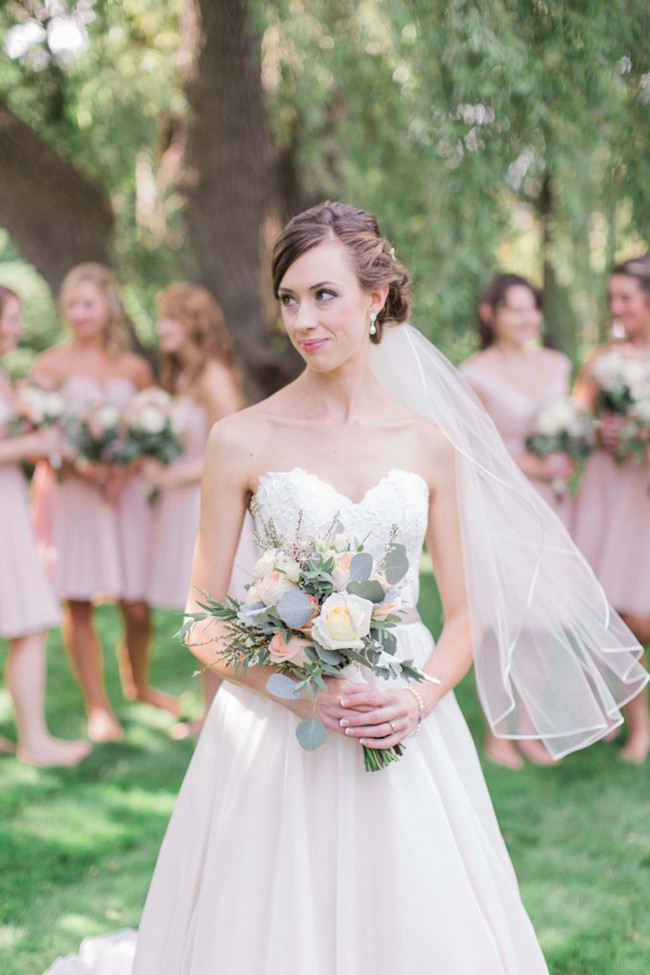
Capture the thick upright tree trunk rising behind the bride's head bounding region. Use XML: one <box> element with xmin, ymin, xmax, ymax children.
<box><xmin>183</xmin><ymin>0</ymin><xmax>300</xmax><ymax>397</ymax></box>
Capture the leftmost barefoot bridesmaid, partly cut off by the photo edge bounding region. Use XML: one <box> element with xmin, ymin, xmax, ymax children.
<box><xmin>0</xmin><ymin>285</ymin><xmax>90</xmax><ymax>766</ymax></box>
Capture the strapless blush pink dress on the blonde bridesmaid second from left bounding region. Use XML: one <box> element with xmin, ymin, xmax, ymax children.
<box><xmin>34</xmin><ymin>376</ymin><xmax>152</xmax><ymax>601</ymax></box>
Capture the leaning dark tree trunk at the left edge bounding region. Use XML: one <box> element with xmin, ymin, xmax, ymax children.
<box><xmin>0</xmin><ymin>99</ymin><xmax>113</xmax><ymax>295</ymax></box>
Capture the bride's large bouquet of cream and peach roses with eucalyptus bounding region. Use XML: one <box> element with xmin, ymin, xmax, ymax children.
<box><xmin>177</xmin><ymin>510</ymin><xmax>439</xmax><ymax>772</ymax></box>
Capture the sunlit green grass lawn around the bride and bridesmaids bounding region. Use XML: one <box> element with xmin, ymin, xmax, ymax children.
<box><xmin>0</xmin><ymin>574</ymin><xmax>650</xmax><ymax>975</ymax></box>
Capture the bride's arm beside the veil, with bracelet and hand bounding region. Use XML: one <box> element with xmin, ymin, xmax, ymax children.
<box><xmin>334</xmin><ymin>431</ymin><xmax>472</xmax><ymax>748</ymax></box>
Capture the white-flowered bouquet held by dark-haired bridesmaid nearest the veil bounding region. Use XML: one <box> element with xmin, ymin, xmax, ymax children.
<box><xmin>526</xmin><ymin>396</ymin><xmax>595</xmax><ymax>501</ymax></box>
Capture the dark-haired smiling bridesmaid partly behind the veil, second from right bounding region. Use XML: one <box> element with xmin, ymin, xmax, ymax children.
<box><xmin>461</xmin><ymin>274</ymin><xmax>575</xmax><ymax>769</ymax></box>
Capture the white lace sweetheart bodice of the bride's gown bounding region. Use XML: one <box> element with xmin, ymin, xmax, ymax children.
<box><xmin>254</xmin><ymin>467</ymin><xmax>429</xmax><ymax>606</ymax></box>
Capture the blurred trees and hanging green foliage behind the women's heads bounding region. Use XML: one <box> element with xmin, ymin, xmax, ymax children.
<box><xmin>0</xmin><ymin>0</ymin><xmax>650</xmax><ymax>395</ymax></box>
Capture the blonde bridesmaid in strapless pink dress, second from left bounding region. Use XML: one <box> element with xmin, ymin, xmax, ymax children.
<box><xmin>35</xmin><ymin>264</ymin><xmax>177</xmax><ymax>741</ymax></box>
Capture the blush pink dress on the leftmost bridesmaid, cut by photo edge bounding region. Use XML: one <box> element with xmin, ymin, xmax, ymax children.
<box><xmin>0</xmin><ymin>388</ymin><xmax>60</xmax><ymax>640</ymax></box>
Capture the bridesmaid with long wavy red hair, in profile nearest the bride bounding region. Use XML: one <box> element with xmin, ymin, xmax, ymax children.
<box><xmin>143</xmin><ymin>284</ymin><xmax>244</xmax><ymax>738</ymax></box>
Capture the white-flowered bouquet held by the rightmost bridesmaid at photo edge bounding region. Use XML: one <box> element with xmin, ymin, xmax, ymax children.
<box><xmin>593</xmin><ymin>351</ymin><xmax>650</xmax><ymax>464</ymax></box>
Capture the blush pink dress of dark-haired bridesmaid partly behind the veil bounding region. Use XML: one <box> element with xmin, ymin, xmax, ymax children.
<box><xmin>460</xmin><ymin>352</ymin><xmax>573</xmax><ymax>527</ymax></box>
